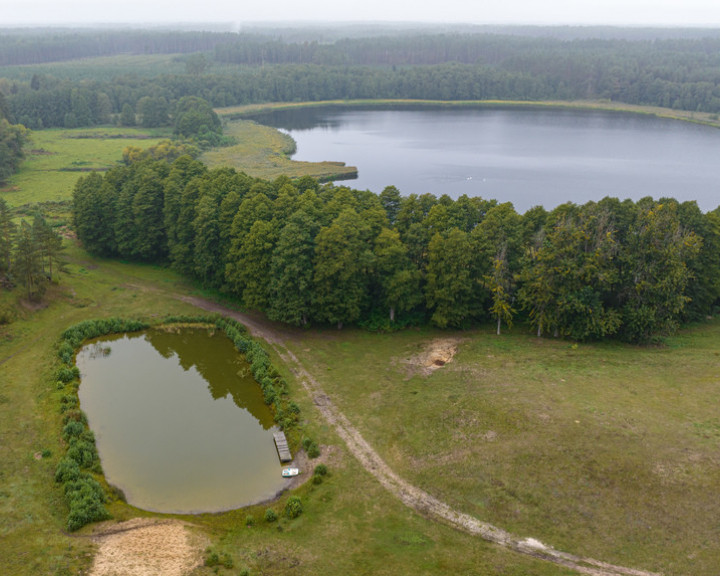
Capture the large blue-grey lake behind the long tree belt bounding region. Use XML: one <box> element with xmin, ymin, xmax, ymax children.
<box><xmin>257</xmin><ymin>109</ymin><xmax>720</xmax><ymax>212</ymax></box>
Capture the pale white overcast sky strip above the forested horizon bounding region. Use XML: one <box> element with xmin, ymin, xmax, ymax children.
<box><xmin>0</xmin><ymin>0</ymin><xmax>720</xmax><ymax>26</ymax></box>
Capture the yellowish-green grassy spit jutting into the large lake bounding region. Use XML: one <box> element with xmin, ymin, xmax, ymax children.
<box><xmin>201</xmin><ymin>120</ymin><xmax>357</xmax><ymax>181</ymax></box>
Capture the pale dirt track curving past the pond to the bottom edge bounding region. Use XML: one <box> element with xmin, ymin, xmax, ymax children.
<box><xmin>181</xmin><ymin>297</ymin><xmax>660</xmax><ymax>576</ymax></box>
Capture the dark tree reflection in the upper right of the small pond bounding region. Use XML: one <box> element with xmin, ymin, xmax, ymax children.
<box><xmin>145</xmin><ymin>328</ymin><xmax>274</xmax><ymax>430</ymax></box>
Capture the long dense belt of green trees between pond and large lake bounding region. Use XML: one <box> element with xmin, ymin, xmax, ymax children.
<box><xmin>73</xmin><ymin>156</ymin><xmax>720</xmax><ymax>342</ymax></box>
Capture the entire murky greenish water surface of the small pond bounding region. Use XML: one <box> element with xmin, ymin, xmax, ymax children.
<box><xmin>77</xmin><ymin>329</ymin><xmax>286</xmax><ymax>513</ymax></box>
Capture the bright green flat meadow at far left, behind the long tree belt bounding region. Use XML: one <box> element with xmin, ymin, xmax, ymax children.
<box><xmin>0</xmin><ymin>126</ymin><xmax>170</xmax><ymax>207</ymax></box>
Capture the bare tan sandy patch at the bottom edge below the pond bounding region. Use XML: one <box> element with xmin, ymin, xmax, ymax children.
<box><xmin>89</xmin><ymin>518</ymin><xmax>204</xmax><ymax>576</ymax></box>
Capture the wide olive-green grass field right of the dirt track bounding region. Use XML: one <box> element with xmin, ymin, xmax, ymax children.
<box><xmin>284</xmin><ymin>320</ymin><xmax>720</xmax><ymax>576</ymax></box>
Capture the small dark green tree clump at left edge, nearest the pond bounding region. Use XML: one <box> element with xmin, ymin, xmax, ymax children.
<box><xmin>0</xmin><ymin>198</ymin><xmax>63</xmax><ymax>300</ymax></box>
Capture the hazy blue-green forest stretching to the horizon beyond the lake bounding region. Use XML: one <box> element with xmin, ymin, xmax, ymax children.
<box><xmin>5</xmin><ymin>29</ymin><xmax>720</xmax><ymax>129</ymax></box>
